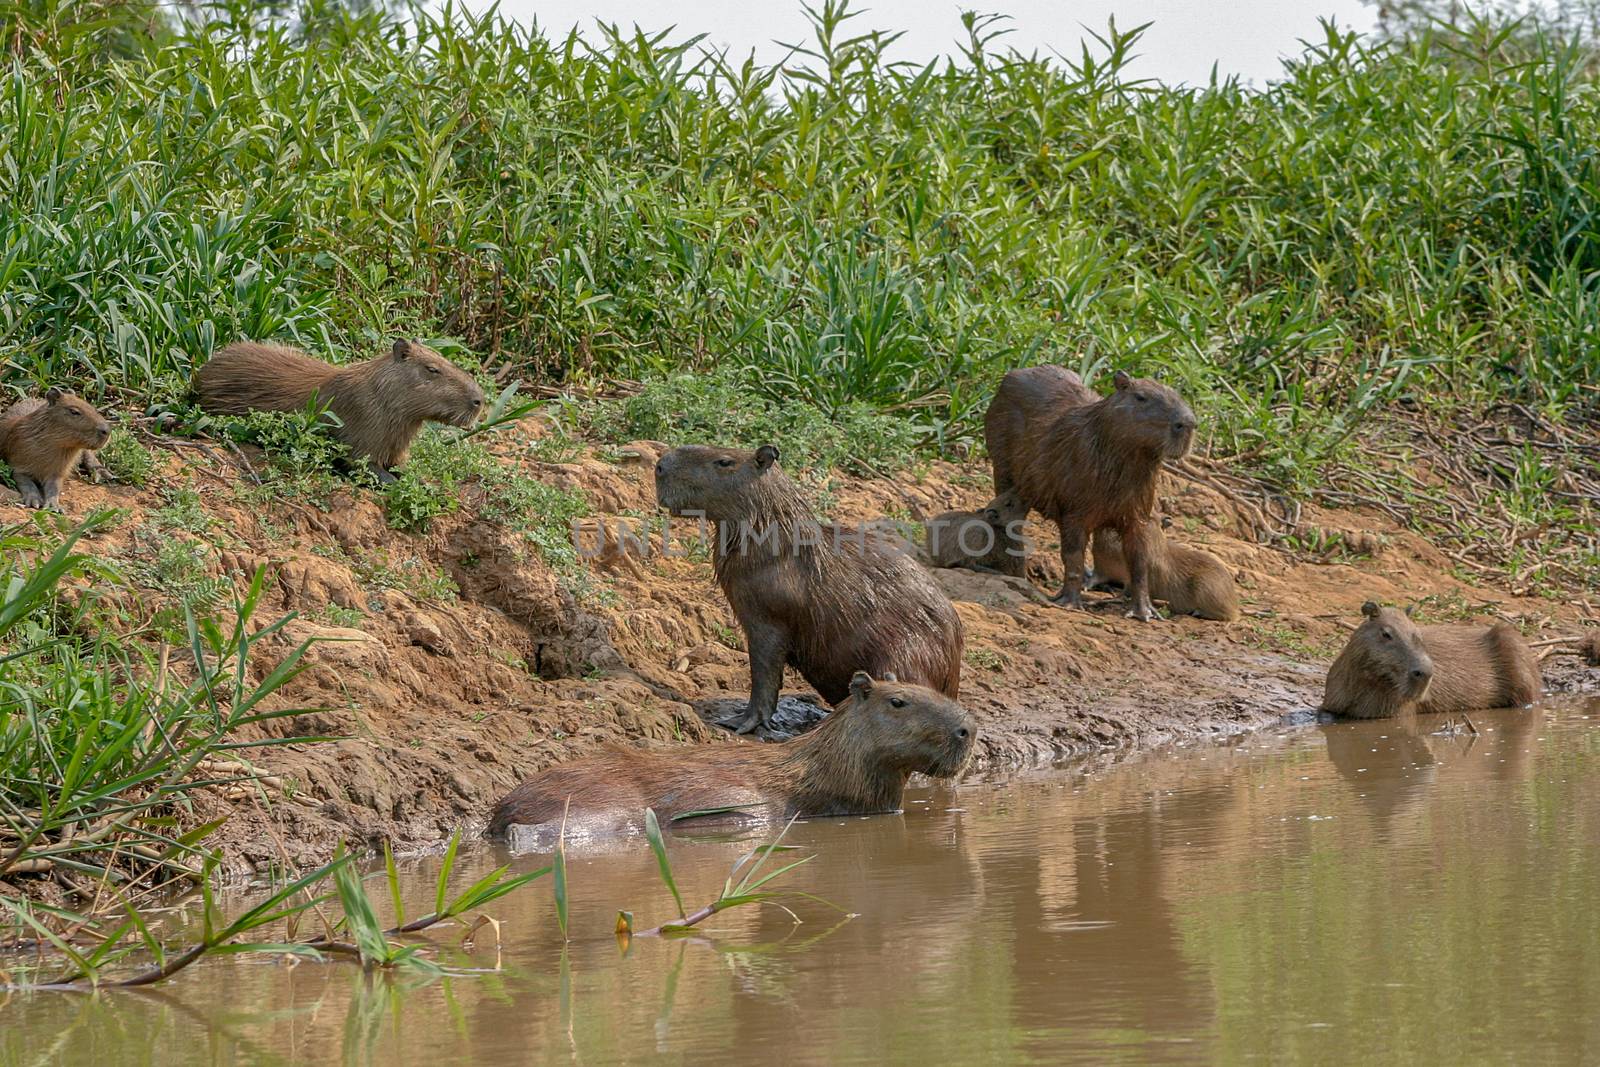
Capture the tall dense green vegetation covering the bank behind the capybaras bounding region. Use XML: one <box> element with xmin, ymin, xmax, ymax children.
<box><xmin>0</xmin><ymin>0</ymin><xmax>1600</xmax><ymax>577</ymax></box>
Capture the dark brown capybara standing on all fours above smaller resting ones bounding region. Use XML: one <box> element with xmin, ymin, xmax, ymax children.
<box><xmin>984</xmin><ymin>366</ymin><xmax>1195</xmax><ymax>619</ymax></box>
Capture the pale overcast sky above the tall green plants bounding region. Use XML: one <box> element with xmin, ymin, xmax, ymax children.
<box><xmin>458</xmin><ymin>0</ymin><xmax>1373</xmax><ymax>85</ymax></box>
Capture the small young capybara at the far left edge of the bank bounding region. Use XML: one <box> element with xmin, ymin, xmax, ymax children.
<box><xmin>0</xmin><ymin>387</ymin><xmax>110</xmax><ymax>507</ymax></box>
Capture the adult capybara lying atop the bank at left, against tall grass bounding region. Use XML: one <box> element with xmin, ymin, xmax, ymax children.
<box><xmin>195</xmin><ymin>338</ymin><xmax>483</xmax><ymax>482</ymax></box>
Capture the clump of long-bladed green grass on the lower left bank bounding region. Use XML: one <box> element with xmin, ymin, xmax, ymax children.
<box><xmin>0</xmin><ymin>515</ymin><xmax>315</xmax><ymax>899</ymax></box>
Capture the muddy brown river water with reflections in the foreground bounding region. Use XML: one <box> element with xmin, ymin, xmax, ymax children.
<box><xmin>0</xmin><ymin>699</ymin><xmax>1600</xmax><ymax>1067</ymax></box>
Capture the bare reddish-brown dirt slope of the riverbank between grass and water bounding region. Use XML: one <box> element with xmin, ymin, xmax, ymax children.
<box><xmin>15</xmin><ymin>424</ymin><xmax>1600</xmax><ymax>869</ymax></box>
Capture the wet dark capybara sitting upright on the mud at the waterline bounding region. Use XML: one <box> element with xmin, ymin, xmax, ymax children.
<box><xmin>656</xmin><ymin>445</ymin><xmax>963</xmax><ymax>733</ymax></box>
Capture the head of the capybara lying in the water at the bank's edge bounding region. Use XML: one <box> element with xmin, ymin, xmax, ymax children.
<box><xmin>840</xmin><ymin>670</ymin><xmax>978</xmax><ymax>777</ymax></box>
